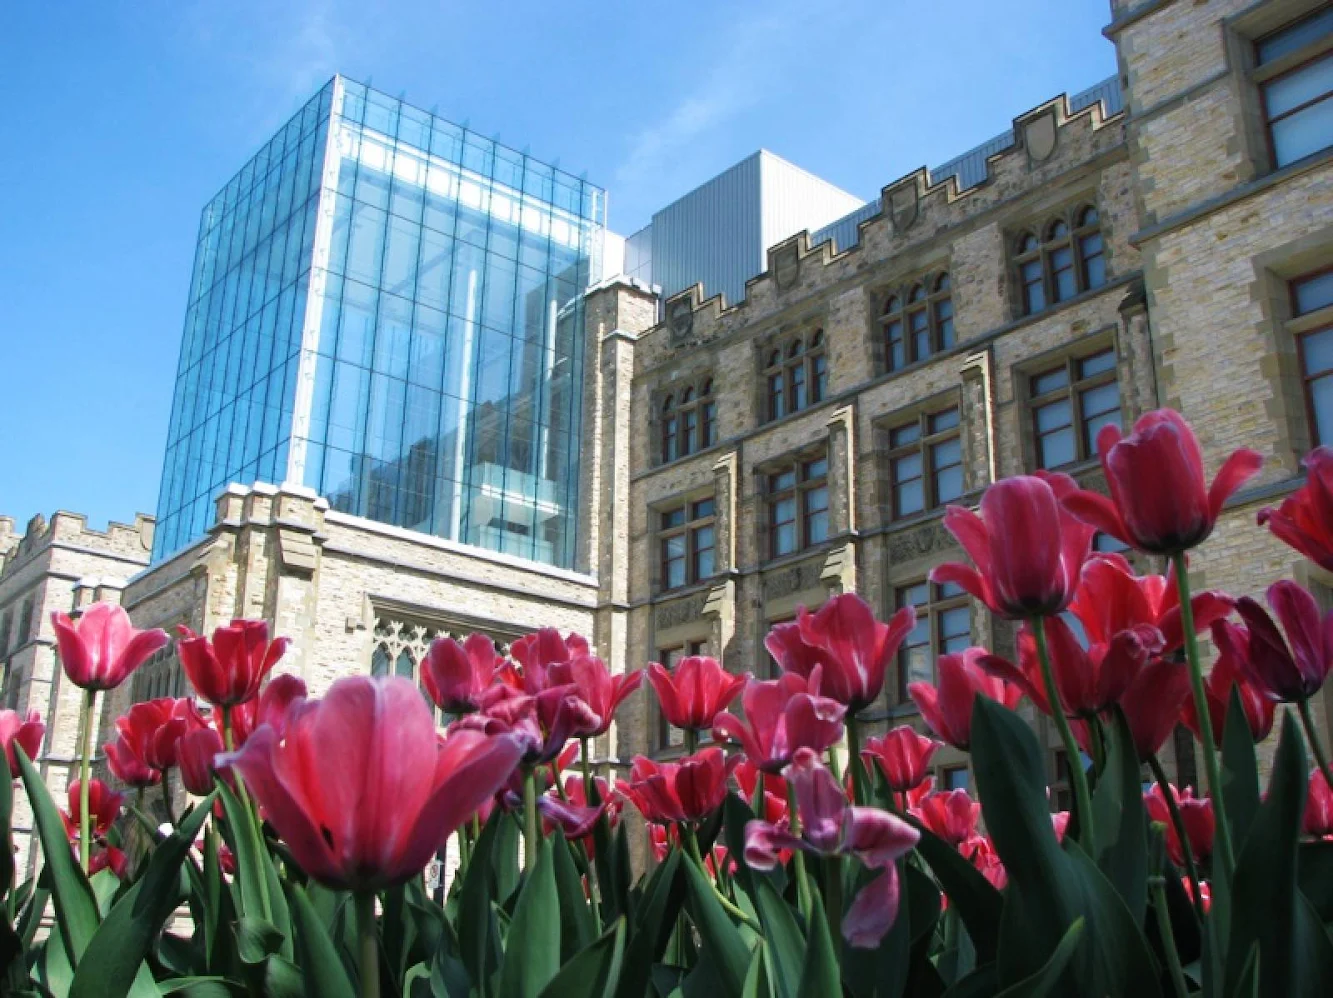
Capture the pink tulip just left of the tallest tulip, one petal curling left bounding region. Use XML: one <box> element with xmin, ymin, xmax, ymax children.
<box><xmin>930</xmin><ymin>472</ymin><xmax>1096</xmax><ymax>620</ymax></box>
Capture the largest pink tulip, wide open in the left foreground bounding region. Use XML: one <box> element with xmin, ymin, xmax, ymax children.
<box><xmin>219</xmin><ymin>676</ymin><xmax>523</xmax><ymax>891</ymax></box>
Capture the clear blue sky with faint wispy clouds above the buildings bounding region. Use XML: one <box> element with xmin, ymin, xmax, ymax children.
<box><xmin>0</xmin><ymin>0</ymin><xmax>1116</xmax><ymax>530</ymax></box>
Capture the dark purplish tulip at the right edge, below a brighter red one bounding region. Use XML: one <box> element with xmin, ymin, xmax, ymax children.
<box><xmin>1214</xmin><ymin>580</ymin><xmax>1333</xmax><ymax>704</ymax></box>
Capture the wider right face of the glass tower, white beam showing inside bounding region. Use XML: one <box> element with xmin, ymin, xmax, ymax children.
<box><xmin>299</xmin><ymin>80</ymin><xmax>605</xmax><ymax>568</ymax></box>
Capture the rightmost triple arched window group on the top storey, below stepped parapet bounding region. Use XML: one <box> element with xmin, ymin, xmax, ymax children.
<box><xmin>1014</xmin><ymin>205</ymin><xmax>1106</xmax><ymax>316</ymax></box>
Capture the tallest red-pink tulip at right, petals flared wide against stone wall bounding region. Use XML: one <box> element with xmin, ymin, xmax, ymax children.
<box><xmin>1064</xmin><ymin>409</ymin><xmax>1264</xmax><ymax>554</ymax></box>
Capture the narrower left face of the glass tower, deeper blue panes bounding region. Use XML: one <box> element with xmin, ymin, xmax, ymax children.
<box><xmin>153</xmin><ymin>81</ymin><xmax>335</xmax><ymax>558</ymax></box>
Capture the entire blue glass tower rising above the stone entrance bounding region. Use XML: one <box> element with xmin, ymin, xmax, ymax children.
<box><xmin>155</xmin><ymin>77</ymin><xmax>605</xmax><ymax>568</ymax></box>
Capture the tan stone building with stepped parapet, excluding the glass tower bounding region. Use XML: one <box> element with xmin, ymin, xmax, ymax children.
<box><xmin>0</xmin><ymin>0</ymin><xmax>1333</xmax><ymax>863</ymax></box>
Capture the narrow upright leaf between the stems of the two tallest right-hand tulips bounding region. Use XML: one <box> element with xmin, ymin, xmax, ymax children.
<box><xmin>1093</xmin><ymin>708</ymin><xmax>1148</xmax><ymax>922</ymax></box>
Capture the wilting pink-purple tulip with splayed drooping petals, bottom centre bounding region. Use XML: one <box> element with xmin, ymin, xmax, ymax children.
<box><xmin>745</xmin><ymin>749</ymin><xmax>921</xmax><ymax>947</ymax></box>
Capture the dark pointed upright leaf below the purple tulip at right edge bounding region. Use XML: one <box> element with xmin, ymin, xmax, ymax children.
<box><xmin>1225</xmin><ymin>713</ymin><xmax>1313</xmax><ymax>995</ymax></box>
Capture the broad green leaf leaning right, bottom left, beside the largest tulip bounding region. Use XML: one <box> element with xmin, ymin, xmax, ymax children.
<box><xmin>69</xmin><ymin>797</ymin><xmax>213</xmax><ymax>998</ymax></box>
